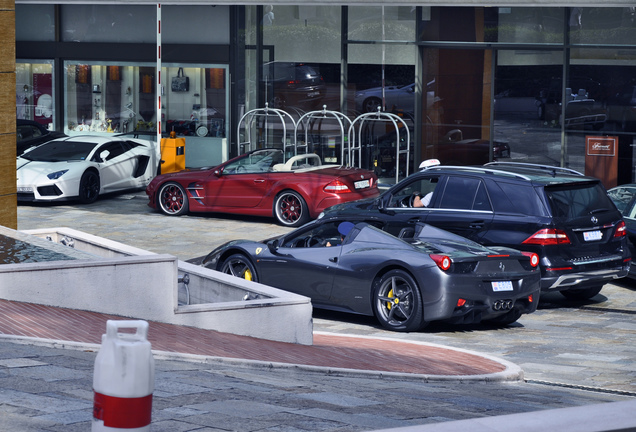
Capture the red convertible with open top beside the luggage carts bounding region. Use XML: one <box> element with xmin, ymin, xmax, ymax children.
<box><xmin>146</xmin><ymin>149</ymin><xmax>379</xmax><ymax>227</ymax></box>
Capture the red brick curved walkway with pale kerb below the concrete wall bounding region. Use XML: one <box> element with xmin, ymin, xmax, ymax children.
<box><xmin>0</xmin><ymin>300</ymin><xmax>523</xmax><ymax>381</ymax></box>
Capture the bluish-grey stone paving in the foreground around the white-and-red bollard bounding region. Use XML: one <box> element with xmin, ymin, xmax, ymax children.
<box><xmin>0</xmin><ymin>339</ymin><xmax>631</xmax><ymax>432</ymax></box>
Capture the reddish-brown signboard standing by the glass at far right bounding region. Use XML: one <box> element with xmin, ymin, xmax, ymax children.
<box><xmin>585</xmin><ymin>136</ymin><xmax>618</xmax><ymax>189</ymax></box>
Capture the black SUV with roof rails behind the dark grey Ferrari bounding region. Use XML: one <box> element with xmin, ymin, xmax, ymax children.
<box><xmin>323</xmin><ymin>162</ymin><xmax>631</xmax><ymax>299</ymax></box>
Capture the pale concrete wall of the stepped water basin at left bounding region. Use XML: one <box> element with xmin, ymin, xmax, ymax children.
<box><xmin>0</xmin><ymin>227</ymin><xmax>313</xmax><ymax>345</ymax></box>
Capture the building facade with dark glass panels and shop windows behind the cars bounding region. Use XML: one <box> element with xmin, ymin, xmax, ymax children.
<box><xmin>0</xmin><ymin>2</ymin><xmax>636</xmax><ymax>225</ymax></box>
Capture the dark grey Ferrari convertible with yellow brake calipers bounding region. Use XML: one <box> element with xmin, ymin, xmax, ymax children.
<box><xmin>202</xmin><ymin>218</ymin><xmax>541</xmax><ymax>331</ymax></box>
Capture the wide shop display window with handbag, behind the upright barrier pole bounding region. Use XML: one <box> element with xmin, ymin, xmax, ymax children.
<box><xmin>64</xmin><ymin>62</ymin><xmax>227</xmax><ymax>137</ymax></box>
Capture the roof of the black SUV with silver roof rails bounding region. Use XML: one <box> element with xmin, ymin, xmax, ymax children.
<box><xmin>422</xmin><ymin>162</ymin><xmax>597</xmax><ymax>185</ymax></box>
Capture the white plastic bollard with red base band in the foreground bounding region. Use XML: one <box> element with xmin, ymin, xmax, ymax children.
<box><xmin>92</xmin><ymin>320</ymin><xmax>155</xmax><ymax>432</ymax></box>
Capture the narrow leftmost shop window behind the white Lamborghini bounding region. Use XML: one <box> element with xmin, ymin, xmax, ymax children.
<box><xmin>15</xmin><ymin>61</ymin><xmax>55</xmax><ymax>129</ymax></box>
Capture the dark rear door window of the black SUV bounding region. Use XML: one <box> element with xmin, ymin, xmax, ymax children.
<box><xmin>439</xmin><ymin>177</ymin><xmax>491</xmax><ymax>210</ymax></box>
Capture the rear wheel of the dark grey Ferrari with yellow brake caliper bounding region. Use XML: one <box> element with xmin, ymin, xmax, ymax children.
<box><xmin>373</xmin><ymin>270</ymin><xmax>427</xmax><ymax>332</ymax></box>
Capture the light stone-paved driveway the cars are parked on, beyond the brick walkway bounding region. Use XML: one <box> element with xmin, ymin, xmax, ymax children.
<box><xmin>13</xmin><ymin>191</ymin><xmax>636</xmax><ymax>397</ymax></box>
